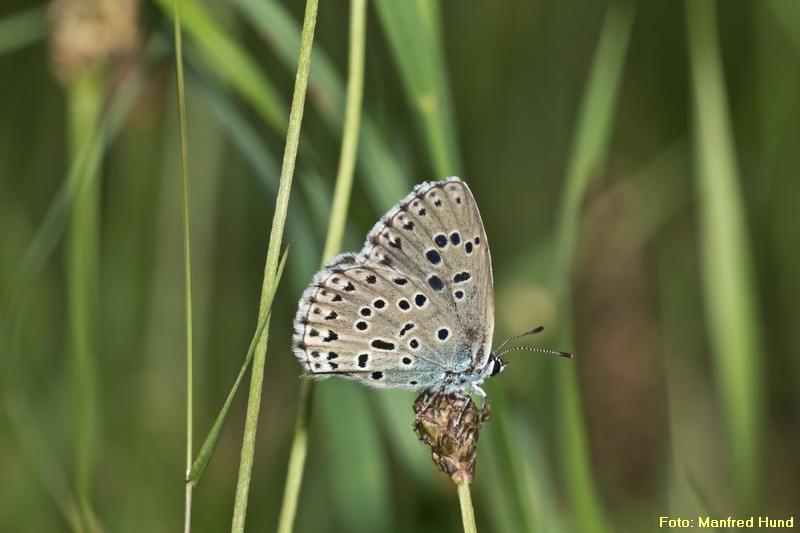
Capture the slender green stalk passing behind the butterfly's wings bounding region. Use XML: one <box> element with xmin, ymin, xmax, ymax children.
<box><xmin>278</xmin><ymin>0</ymin><xmax>367</xmax><ymax>533</ymax></box>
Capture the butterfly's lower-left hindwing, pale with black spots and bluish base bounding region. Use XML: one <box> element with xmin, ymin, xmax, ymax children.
<box><xmin>295</xmin><ymin>255</ymin><xmax>454</xmax><ymax>389</ymax></box>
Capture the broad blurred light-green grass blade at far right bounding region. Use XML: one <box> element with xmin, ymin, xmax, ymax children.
<box><xmin>686</xmin><ymin>1</ymin><xmax>763</xmax><ymax>513</ymax></box>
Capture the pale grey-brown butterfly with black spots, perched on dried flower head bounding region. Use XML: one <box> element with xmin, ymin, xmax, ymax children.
<box><xmin>293</xmin><ymin>178</ymin><xmax>505</xmax><ymax>394</ymax></box>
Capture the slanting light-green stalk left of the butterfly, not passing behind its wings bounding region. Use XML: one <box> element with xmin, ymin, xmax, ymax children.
<box><xmin>231</xmin><ymin>0</ymin><xmax>318</xmax><ymax>532</ymax></box>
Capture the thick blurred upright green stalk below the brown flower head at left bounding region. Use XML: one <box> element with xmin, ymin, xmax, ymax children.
<box><xmin>67</xmin><ymin>72</ymin><xmax>105</xmax><ymax>531</ymax></box>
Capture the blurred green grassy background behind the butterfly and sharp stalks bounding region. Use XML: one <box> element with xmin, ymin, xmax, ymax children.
<box><xmin>0</xmin><ymin>0</ymin><xmax>800</xmax><ymax>532</ymax></box>
